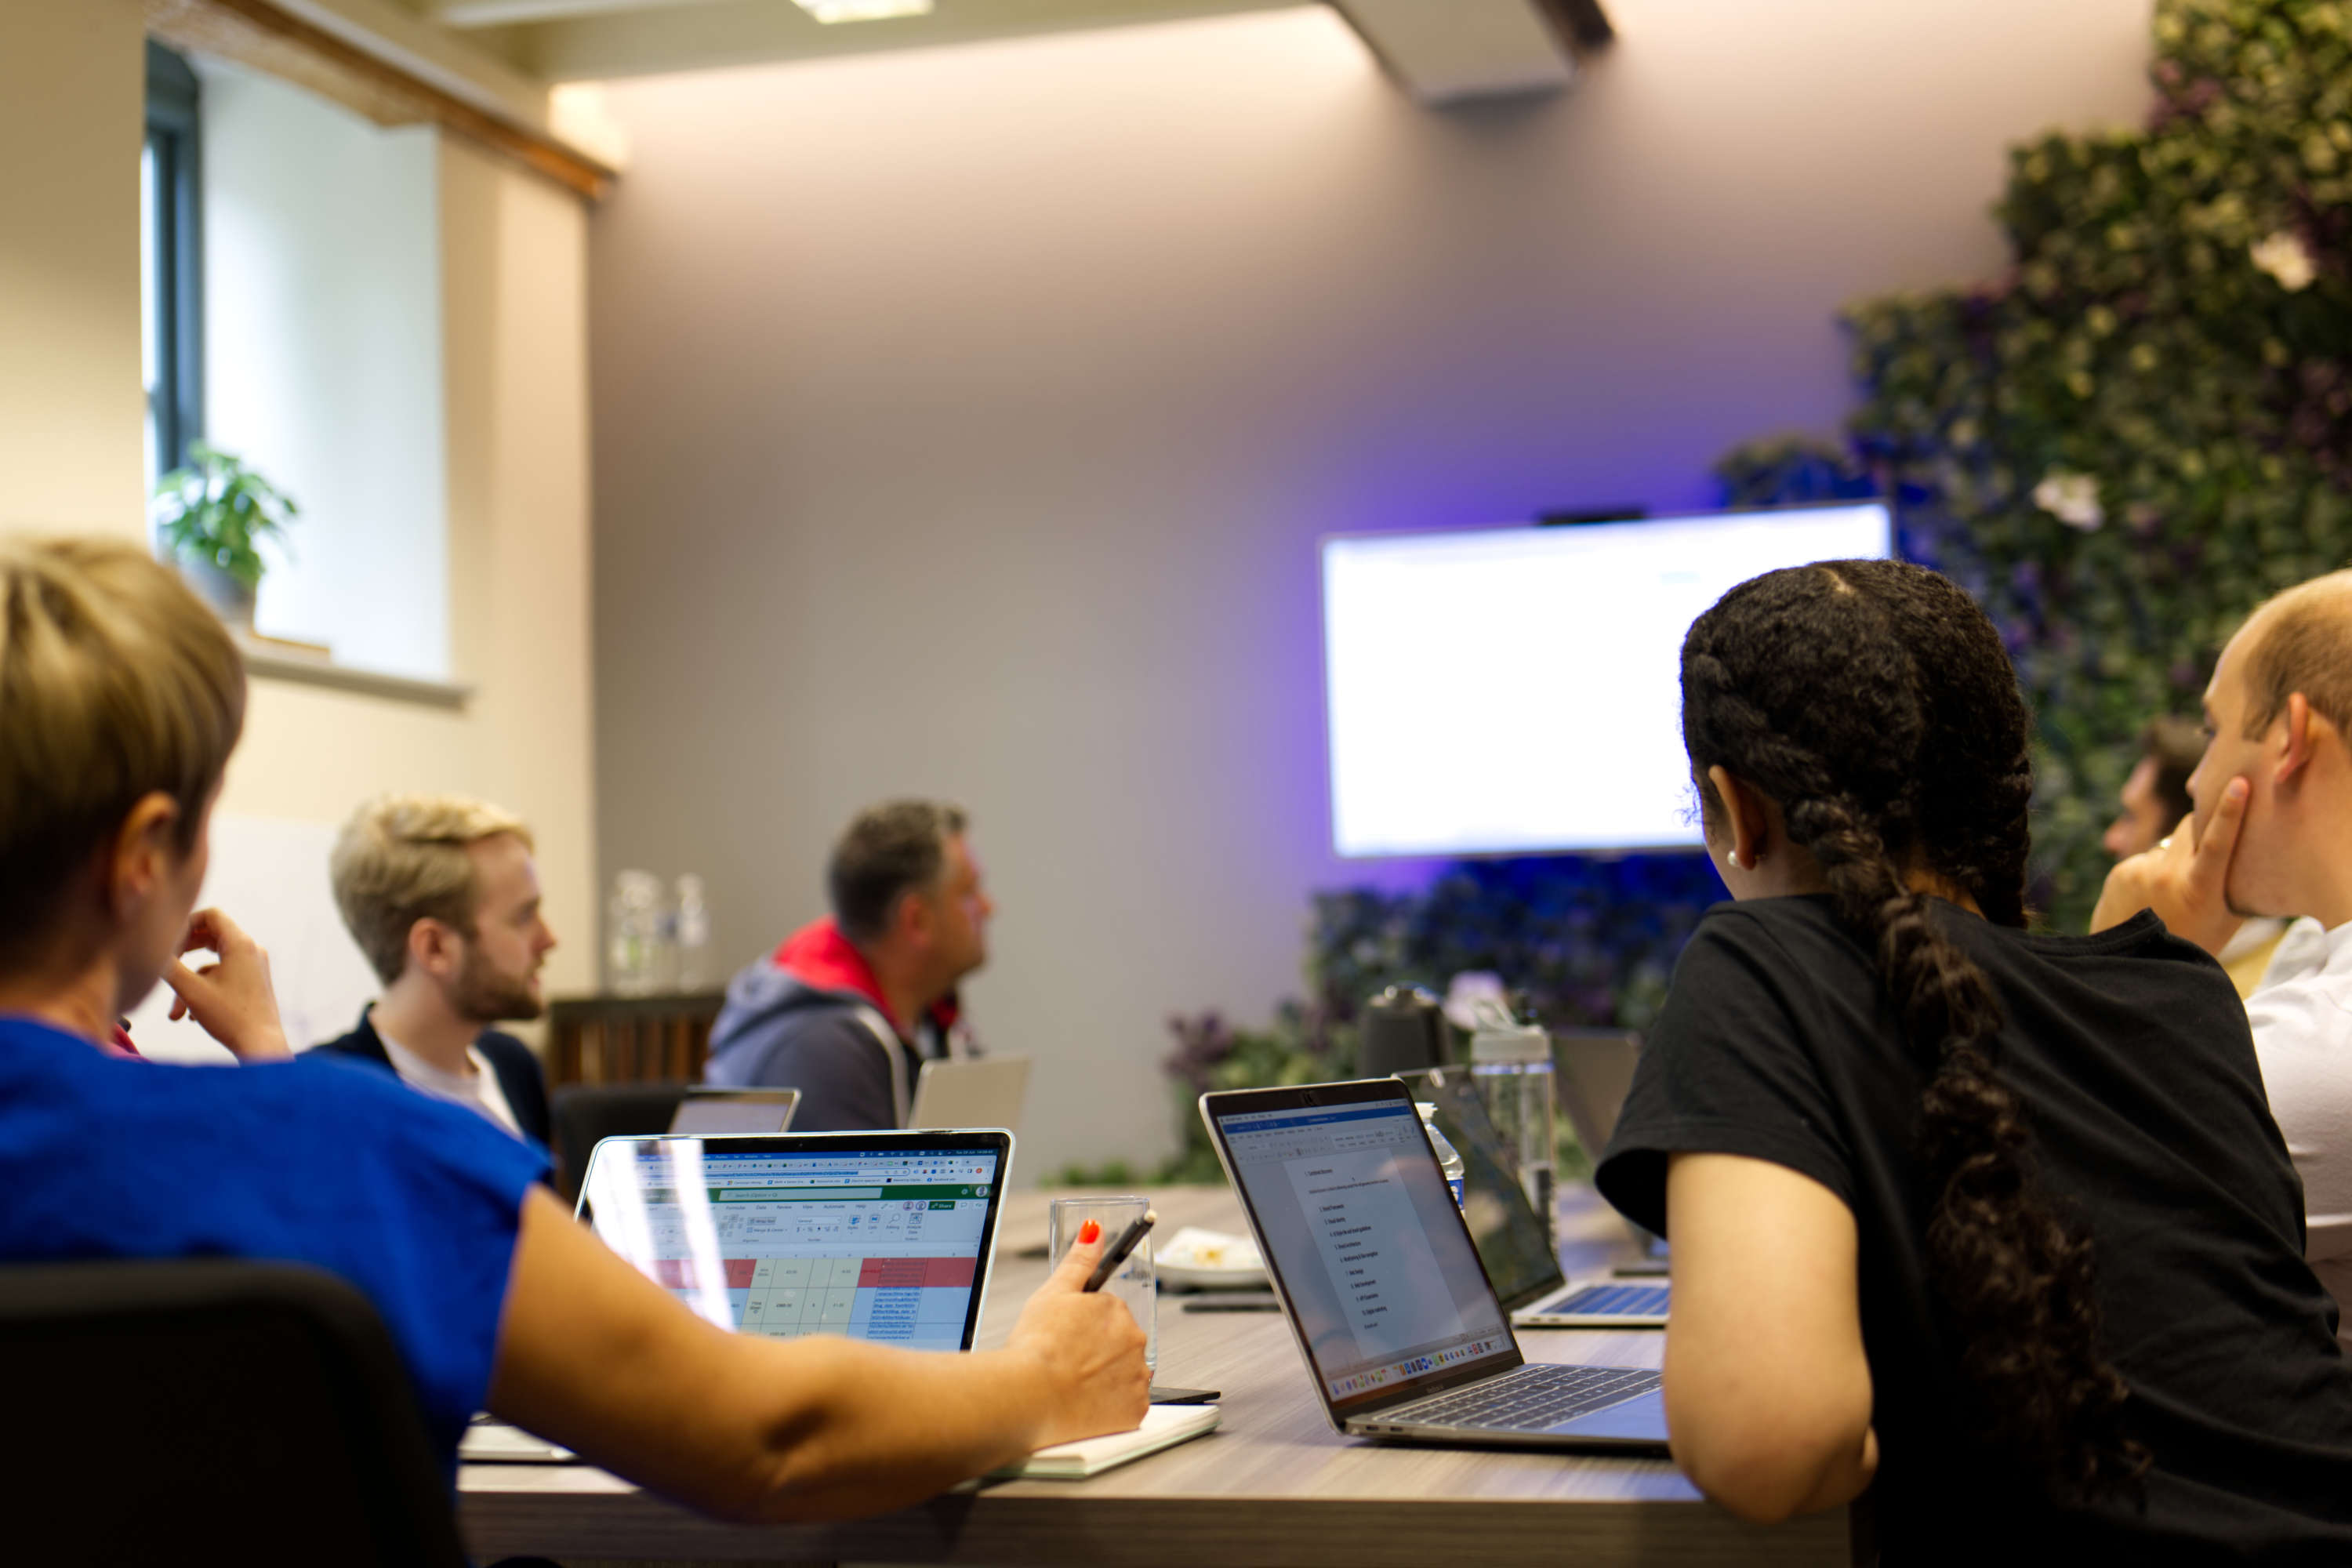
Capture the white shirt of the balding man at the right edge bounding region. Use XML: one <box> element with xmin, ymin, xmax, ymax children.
<box><xmin>2246</xmin><ymin>919</ymin><xmax>2352</xmax><ymax>1349</ymax></box>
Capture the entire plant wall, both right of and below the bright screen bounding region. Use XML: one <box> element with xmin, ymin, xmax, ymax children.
<box><xmin>1082</xmin><ymin>0</ymin><xmax>2352</xmax><ymax>1180</ymax></box>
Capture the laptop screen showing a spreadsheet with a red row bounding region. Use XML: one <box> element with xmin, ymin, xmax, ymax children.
<box><xmin>581</xmin><ymin>1133</ymin><xmax>1011</xmax><ymax>1349</ymax></box>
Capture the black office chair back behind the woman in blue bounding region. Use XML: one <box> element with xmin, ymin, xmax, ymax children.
<box><xmin>0</xmin><ymin>1258</ymin><xmax>466</xmax><ymax>1568</ymax></box>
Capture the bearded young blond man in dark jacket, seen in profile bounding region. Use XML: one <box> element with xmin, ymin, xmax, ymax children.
<box><xmin>320</xmin><ymin>794</ymin><xmax>555</xmax><ymax>1142</ymax></box>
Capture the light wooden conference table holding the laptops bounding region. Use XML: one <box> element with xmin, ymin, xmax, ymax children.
<box><xmin>459</xmin><ymin>1187</ymin><xmax>1849</xmax><ymax>1568</ymax></box>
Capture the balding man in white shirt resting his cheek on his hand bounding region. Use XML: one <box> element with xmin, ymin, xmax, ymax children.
<box><xmin>2091</xmin><ymin>572</ymin><xmax>2352</xmax><ymax>1349</ymax></box>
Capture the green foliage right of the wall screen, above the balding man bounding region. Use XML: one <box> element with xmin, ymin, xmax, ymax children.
<box><xmin>1726</xmin><ymin>0</ymin><xmax>2352</xmax><ymax>928</ymax></box>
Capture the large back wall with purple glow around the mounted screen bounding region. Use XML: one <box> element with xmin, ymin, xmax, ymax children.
<box><xmin>593</xmin><ymin>0</ymin><xmax>2150</xmax><ymax>1173</ymax></box>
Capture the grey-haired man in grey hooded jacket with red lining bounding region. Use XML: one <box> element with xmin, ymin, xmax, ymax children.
<box><xmin>703</xmin><ymin>799</ymin><xmax>995</xmax><ymax>1133</ymax></box>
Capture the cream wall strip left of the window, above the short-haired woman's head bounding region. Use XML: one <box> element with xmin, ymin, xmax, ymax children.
<box><xmin>0</xmin><ymin>0</ymin><xmax>146</xmax><ymax>539</ymax></box>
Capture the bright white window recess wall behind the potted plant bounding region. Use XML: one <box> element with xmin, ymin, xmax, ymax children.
<box><xmin>202</xmin><ymin>64</ymin><xmax>449</xmax><ymax>680</ymax></box>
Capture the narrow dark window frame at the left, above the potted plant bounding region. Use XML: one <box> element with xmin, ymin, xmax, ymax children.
<box><xmin>143</xmin><ymin>38</ymin><xmax>205</xmax><ymax>477</ymax></box>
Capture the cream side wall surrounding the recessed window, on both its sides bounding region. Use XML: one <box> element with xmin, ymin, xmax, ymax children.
<box><xmin>0</xmin><ymin>0</ymin><xmax>595</xmax><ymax>1053</ymax></box>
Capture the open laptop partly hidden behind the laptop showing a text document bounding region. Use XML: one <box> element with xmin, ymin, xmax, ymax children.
<box><xmin>1397</xmin><ymin>1067</ymin><xmax>1668</xmax><ymax>1328</ymax></box>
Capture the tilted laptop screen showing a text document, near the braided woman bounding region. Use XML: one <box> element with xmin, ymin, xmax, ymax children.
<box><xmin>1216</xmin><ymin>1079</ymin><xmax>1519</xmax><ymax>1410</ymax></box>
